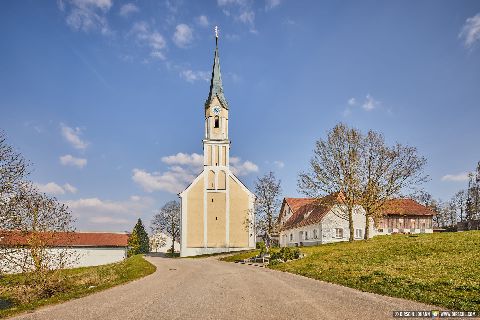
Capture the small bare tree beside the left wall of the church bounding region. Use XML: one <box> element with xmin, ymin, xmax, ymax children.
<box><xmin>151</xmin><ymin>200</ymin><xmax>181</xmax><ymax>253</ymax></box>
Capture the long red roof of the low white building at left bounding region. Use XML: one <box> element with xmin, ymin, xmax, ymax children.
<box><xmin>0</xmin><ymin>231</ymin><xmax>129</xmax><ymax>247</ymax></box>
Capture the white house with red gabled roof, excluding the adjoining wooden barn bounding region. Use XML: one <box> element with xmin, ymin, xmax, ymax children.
<box><xmin>278</xmin><ymin>198</ymin><xmax>374</xmax><ymax>247</ymax></box>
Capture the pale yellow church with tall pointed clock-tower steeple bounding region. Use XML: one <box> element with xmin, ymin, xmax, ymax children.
<box><xmin>179</xmin><ymin>28</ymin><xmax>255</xmax><ymax>257</ymax></box>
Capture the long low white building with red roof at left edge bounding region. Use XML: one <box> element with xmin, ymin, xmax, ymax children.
<box><xmin>0</xmin><ymin>231</ymin><xmax>129</xmax><ymax>273</ymax></box>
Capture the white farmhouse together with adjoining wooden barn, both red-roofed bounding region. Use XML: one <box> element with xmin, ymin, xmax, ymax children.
<box><xmin>278</xmin><ymin>196</ymin><xmax>435</xmax><ymax>246</ymax></box>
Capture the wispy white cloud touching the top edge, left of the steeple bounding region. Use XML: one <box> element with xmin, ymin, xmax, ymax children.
<box><xmin>59</xmin><ymin>0</ymin><xmax>112</xmax><ymax>35</ymax></box>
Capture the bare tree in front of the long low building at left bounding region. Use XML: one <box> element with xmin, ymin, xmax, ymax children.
<box><xmin>0</xmin><ymin>183</ymin><xmax>77</xmax><ymax>284</ymax></box>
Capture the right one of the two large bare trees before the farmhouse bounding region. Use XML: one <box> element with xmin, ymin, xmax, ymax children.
<box><xmin>358</xmin><ymin>130</ymin><xmax>427</xmax><ymax>239</ymax></box>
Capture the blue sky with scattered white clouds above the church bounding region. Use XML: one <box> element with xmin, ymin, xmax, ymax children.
<box><xmin>0</xmin><ymin>0</ymin><xmax>480</xmax><ymax>231</ymax></box>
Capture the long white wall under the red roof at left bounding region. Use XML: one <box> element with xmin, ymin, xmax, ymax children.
<box><xmin>0</xmin><ymin>247</ymin><xmax>127</xmax><ymax>273</ymax></box>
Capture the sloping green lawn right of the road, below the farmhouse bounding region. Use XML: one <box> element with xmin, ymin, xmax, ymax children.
<box><xmin>223</xmin><ymin>231</ymin><xmax>480</xmax><ymax>312</ymax></box>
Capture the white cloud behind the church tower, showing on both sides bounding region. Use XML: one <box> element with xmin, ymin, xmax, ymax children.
<box><xmin>132</xmin><ymin>153</ymin><xmax>258</xmax><ymax>194</ymax></box>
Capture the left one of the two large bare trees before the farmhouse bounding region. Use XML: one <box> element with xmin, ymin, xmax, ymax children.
<box><xmin>298</xmin><ymin>124</ymin><xmax>362</xmax><ymax>241</ymax></box>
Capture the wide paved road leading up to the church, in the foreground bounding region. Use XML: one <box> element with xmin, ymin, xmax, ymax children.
<box><xmin>16</xmin><ymin>257</ymin><xmax>432</xmax><ymax>320</ymax></box>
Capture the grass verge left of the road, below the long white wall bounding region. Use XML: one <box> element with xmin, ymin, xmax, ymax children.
<box><xmin>0</xmin><ymin>255</ymin><xmax>156</xmax><ymax>318</ymax></box>
